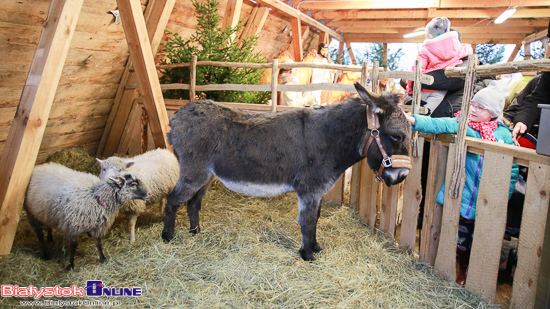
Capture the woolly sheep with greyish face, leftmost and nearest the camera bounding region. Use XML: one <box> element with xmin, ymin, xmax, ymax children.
<box><xmin>24</xmin><ymin>163</ymin><xmax>148</xmax><ymax>270</ymax></box>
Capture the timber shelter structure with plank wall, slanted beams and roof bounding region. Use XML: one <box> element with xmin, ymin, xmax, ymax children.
<box><xmin>0</xmin><ymin>0</ymin><xmax>550</xmax><ymax>304</ymax></box>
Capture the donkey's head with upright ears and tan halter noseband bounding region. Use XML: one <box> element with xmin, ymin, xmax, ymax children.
<box><xmin>355</xmin><ymin>83</ymin><xmax>411</xmax><ymax>186</ymax></box>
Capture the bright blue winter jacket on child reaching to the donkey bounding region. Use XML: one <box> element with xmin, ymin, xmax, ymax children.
<box><xmin>412</xmin><ymin>115</ymin><xmax>519</xmax><ymax>219</ymax></box>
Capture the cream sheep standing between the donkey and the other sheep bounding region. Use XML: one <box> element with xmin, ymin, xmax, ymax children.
<box><xmin>97</xmin><ymin>148</ymin><xmax>179</xmax><ymax>241</ymax></box>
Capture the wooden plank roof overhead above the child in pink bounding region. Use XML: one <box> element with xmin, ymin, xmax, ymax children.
<box><xmin>280</xmin><ymin>0</ymin><xmax>550</xmax><ymax>44</ymax></box>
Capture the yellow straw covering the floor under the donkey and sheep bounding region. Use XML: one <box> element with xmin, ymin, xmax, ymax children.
<box><xmin>0</xmin><ymin>149</ymin><xmax>496</xmax><ymax>308</ymax></box>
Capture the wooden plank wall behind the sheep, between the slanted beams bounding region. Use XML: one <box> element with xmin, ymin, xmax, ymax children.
<box><xmin>0</xmin><ymin>0</ymin><xmax>146</xmax><ymax>162</ymax></box>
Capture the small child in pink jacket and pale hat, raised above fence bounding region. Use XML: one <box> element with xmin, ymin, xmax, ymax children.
<box><xmin>407</xmin><ymin>17</ymin><xmax>473</xmax><ymax>112</ymax></box>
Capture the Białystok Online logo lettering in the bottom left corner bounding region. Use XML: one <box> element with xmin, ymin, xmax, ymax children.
<box><xmin>1</xmin><ymin>280</ymin><xmax>142</xmax><ymax>299</ymax></box>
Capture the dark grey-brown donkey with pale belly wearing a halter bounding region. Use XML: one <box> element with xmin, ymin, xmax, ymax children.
<box><xmin>162</xmin><ymin>83</ymin><xmax>411</xmax><ymax>261</ymax></box>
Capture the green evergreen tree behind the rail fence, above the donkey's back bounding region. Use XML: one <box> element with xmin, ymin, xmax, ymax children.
<box><xmin>161</xmin><ymin>0</ymin><xmax>271</xmax><ymax>104</ymax></box>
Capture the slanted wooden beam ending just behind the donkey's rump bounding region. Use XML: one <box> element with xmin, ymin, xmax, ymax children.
<box><xmin>117</xmin><ymin>0</ymin><xmax>168</xmax><ymax>148</ymax></box>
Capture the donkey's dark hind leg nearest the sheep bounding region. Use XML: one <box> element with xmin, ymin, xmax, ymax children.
<box><xmin>162</xmin><ymin>171</ymin><xmax>210</xmax><ymax>242</ymax></box>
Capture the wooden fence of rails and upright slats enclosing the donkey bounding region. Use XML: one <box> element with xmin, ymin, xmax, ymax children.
<box><xmin>149</xmin><ymin>57</ymin><xmax>550</xmax><ymax>308</ymax></box>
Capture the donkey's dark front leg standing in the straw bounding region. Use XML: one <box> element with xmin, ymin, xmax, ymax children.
<box><xmin>298</xmin><ymin>193</ymin><xmax>323</xmax><ymax>261</ymax></box>
